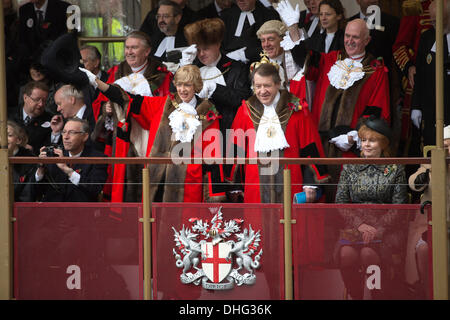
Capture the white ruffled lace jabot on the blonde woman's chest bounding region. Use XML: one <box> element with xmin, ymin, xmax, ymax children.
<box><xmin>169</xmin><ymin>96</ymin><xmax>201</xmax><ymax>143</ymax></box>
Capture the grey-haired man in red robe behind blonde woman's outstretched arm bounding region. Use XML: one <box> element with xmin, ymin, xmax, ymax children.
<box><xmin>92</xmin><ymin>31</ymin><xmax>173</xmax><ymax>202</ymax></box>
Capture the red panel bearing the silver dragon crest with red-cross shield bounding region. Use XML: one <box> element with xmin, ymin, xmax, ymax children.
<box><xmin>152</xmin><ymin>203</ymin><xmax>284</xmax><ymax>300</ymax></box>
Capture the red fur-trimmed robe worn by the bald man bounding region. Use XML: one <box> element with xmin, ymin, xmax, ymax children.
<box><xmin>307</xmin><ymin>51</ymin><xmax>390</xmax><ymax>132</ymax></box>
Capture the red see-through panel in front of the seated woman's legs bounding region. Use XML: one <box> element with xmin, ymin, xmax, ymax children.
<box><xmin>292</xmin><ymin>204</ymin><xmax>432</xmax><ymax>300</ymax></box>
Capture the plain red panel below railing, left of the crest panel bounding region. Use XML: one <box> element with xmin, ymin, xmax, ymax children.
<box><xmin>14</xmin><ymin>203</ymin><xmax>143</xmax><ymax>300</ymax></box>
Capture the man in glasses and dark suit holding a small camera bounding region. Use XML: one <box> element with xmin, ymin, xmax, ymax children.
<box><xmin>34</xmin><ymin>118</ymin><xmax>107</xmax><ymax>202</ymax></box>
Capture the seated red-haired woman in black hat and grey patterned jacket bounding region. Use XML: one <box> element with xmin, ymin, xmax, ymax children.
<box><xmin>335</xmin><ymin>117</ymin><xmax>407</xmax><ymax>299</ymax></box>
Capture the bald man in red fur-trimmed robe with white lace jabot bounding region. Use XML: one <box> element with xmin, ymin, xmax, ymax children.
<box><xmin>287</xmin><ymin>19</ymin><xmax>390</xmax><ymax>157</ymax></box>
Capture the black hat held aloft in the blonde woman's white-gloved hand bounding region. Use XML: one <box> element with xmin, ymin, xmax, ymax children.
<box><xmin>41</xmin><ymin>32</ymin><xmax>89</xmax><ymax>89</ymax></box>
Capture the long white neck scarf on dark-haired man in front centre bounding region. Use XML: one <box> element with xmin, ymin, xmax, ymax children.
<box><xmin>254</xmin><ymin>92</ymin><xmax>289</xmax><ymax>153</ymax></box>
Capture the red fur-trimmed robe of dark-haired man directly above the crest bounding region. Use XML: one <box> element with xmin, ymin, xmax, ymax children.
<box><xmin>231</xmin><ymin>90</ymin><xmax>328</xmax><ymax>203</ymax></box>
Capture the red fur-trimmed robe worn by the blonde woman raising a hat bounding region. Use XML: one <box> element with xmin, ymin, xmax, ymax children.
<box><xmin>116</xmin><ymin>95</ymin><xmax>225</xmax><ymax>202</ymax></box>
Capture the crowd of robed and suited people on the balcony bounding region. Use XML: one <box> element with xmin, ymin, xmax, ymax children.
<box><xmin>4</xmin><ymin>0</ymin><xmax>450</xmax><ymax>299</ymax></box>
